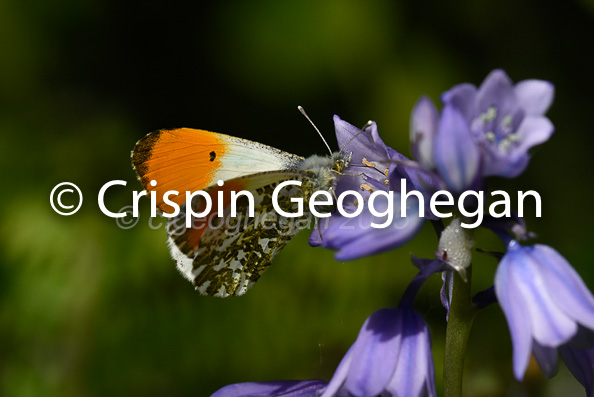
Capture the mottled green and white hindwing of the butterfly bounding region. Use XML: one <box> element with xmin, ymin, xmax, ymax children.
<box><xmin>167</xmin><ymin>170</ymin><xmax>319</xmax><ymax>297</ymax></box>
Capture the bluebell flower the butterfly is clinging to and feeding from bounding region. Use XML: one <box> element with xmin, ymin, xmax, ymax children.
<box><xmin>309</xmin><ymin>116</ymin><xmax>434</xmax><ymax>260</ymax></box>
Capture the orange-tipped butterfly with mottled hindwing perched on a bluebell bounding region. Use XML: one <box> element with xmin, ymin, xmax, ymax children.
<box><xmin>132</xmin><ymin>128</ymin><xmax>351</xmax><ymax>297</ymax></box>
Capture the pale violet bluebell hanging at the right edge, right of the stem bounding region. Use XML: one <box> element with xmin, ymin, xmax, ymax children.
<box><xmin>495</xmin><ymin>240</ymin><xmax>594</xmax><ymax>380</ymax></box>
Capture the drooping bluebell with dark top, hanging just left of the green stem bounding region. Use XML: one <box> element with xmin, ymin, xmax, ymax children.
<box><xmin>322</xmin><ymin>307</ymin><xmax>436</xmax><ymax>397</ymax></box>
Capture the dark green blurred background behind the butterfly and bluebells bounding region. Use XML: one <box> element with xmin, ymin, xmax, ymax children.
<box><xmin>0</xmin><ymin>0</ymin><xmax>594</xmax><ymax>396</ymax></box>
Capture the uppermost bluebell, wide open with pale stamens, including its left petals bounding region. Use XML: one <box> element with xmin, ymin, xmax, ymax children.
<box><xmin>410</xmin><ymin>70</ymin><xmax>554</xmax><ymax>193</ymax></box>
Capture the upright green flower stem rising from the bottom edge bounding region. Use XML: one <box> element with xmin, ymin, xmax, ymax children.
<box><xmin>443</xmin><ymin>266</ymin><xmax>476</xmax><ymax>397</ymax></box>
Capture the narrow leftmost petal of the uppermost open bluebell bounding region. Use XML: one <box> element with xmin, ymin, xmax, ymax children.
<box><xmin>410</xmin><ymin>96</ymin><xmax>439</xmax><ymax>170</ymax></box>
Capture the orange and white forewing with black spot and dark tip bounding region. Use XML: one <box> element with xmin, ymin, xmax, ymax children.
<box><xmin>132</xmin><ymin>128</ymin><xmax>303</xmax><ymax>213</ymax></box>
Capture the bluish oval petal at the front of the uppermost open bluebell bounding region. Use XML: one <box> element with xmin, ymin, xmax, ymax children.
<box><xmin>434</xmin><ymin>106</ymin><xmax>480</xmax><ymax>193</ymax></box>
